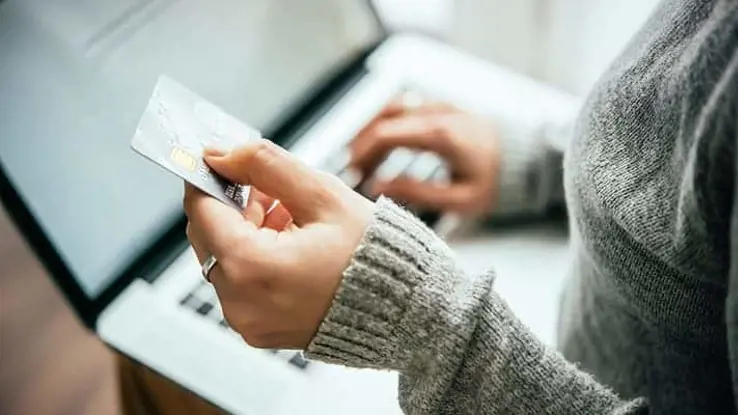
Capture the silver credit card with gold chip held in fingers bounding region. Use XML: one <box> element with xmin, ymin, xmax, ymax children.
<box><xmin>131</xmin><ymin>76</ymin><xmax>261</xmax><ymax>210</ymax></box>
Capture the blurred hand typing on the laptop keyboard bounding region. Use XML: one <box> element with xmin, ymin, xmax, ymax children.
<box><xmin>350</xmin><ymin>94</ymin><xmax>500</xmax><ymax>214</ymax></box>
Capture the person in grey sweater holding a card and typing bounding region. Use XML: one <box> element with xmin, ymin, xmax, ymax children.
<box><xmin>185</xmin><ymin>0</ymin><xmax>738</xmax><ymax>414</ymax></box>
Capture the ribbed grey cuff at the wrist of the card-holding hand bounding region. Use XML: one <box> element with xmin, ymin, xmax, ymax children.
<box><xmin>306</xmin><ymin>198</ymin><xmax>462</xmax><ymax>370</ymax></box>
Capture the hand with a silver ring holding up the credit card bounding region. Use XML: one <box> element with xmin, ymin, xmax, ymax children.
<box><xmin>184</xmin><ymin>140</ymin><xmax>374</xmax><ymax>349</ymax></box>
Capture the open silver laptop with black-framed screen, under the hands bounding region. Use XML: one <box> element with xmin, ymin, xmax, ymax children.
<box><xmin>0</xmin><ymin>0</ymin><xmax>570</xmax><ymax>415</ymax></box>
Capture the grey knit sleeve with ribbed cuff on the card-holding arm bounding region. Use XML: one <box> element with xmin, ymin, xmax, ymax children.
<box><xmin>306</xmin><ymin>199</ymin><xmax>645</xmax><ymax>414</ymax></box>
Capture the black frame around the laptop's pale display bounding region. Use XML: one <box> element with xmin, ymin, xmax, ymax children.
<box><xmin>0</xmin><ymin>0</ymin><xmax>389</xmax><ymax>331</ymax></box>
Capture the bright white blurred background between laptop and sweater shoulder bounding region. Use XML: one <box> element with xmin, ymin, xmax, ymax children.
<box><xmin>374</xmin><ymin>0</ymin><xmax>659</xmax><ymax>95</ymax></box>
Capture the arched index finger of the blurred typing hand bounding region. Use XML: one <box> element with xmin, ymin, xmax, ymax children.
<box><xmin>352</xmin><ymin>115</ymin><xmax>454</xmax><ymax>173</ymax></box>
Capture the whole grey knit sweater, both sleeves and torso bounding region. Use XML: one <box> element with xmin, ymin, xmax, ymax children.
<box><xmin>308</xmin><ymin>0</ymin><xmax>738</xmax><ymax>414</ymax></box>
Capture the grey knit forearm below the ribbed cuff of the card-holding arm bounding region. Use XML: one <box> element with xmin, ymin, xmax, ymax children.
<box><xmin>436</xmin><ymin>293</ymin><xmax>645</xmax><ymax>415</ymax></box>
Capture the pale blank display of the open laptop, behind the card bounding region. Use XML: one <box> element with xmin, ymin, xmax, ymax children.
<box><xmin>0</xmin><ymin>0</ymin><xmax>380</xmax><ymax>298</ymax></box>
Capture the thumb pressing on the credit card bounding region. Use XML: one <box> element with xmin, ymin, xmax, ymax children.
<box><xmin>204</xmin><ymin>139</ymin><xmax>329</xmax><ymax>226</ymax></box>
